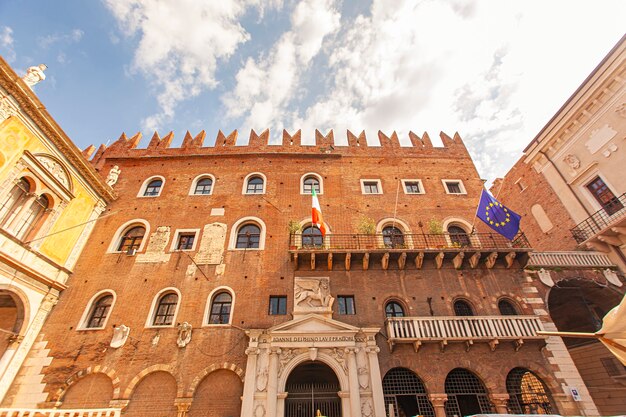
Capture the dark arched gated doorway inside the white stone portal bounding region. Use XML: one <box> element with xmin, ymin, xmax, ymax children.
<box><xmin>285</xmin><ymin>361</ymin><xmax>341</xmax><ymax>417</ymax></box>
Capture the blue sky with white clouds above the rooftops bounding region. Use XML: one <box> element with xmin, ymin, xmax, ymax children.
<box><xmin>0</xmin><ymin>0</ymin><xmax>626</xmax><ymax>182</ymax></box>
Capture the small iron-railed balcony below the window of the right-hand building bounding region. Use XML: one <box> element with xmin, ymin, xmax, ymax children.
<box><xmin>571</xmin><ymin>193</ymin><xmax>626</xmax><ymax>245</ymax></box>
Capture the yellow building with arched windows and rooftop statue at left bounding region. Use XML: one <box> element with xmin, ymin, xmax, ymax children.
<box><xmin>0</xmin><ymin>58</ymin><xmax>114</xmax><ymax>404</ymax></box>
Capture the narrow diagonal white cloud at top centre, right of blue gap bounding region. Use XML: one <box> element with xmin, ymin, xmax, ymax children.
<box><xmin>222</xmin><ymin>0</ymin><xmax>340</xmax><ymax>131</ymax></box>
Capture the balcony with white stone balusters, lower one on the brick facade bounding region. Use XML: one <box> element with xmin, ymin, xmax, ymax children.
<box><xmin>386</xmin><ymin>316</ymin><xmax>545</xmax><ymax>352</ymax></box>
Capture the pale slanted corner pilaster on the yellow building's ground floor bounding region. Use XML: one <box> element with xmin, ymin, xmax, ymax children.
<box><xmin>0</xmin><ymin>293</ymin><xmax>59</xmax><ymax>401</ymax></box>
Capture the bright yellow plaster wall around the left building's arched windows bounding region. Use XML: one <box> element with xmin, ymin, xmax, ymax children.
<box><xmin>0</xmin><ymin>117</ymin><xmax>96</xmax><ymax>264</ymax></box>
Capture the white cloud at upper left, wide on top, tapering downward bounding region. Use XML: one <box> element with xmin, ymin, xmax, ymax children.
<box><xmin>105</xmin><ymin>0</ymin><xmax>282</xmax><ymax>130</ymax></box>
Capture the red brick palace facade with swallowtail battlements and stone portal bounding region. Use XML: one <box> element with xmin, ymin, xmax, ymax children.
<box><xmin>0</xmin><ymin>131</ymin><xmax>598</xmax><ymax>417</ymax></box>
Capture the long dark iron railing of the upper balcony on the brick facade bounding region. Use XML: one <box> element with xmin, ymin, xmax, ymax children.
<box><xmin>289</xmin><ymin>233</ymin><xmax>530</xmax><ymax>251</ymax></box>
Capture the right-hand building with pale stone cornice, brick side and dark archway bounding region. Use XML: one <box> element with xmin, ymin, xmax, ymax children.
<box><xmin>492</xmin><ymin>37</ymin><xmax>626</xmax><ymax>415</ymax></box>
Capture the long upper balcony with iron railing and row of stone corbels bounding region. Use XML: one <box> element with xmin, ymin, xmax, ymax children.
<box><xmin>289</xmin><ymin>233</ymin><xmax>532</xmax><ymax>271</ymax></box>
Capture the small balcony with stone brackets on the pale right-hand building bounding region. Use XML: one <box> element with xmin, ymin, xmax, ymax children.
<box><xmin>571</xmin><ymin>193</ymin><xmax>626</xmax><ymax>252</ymax></box>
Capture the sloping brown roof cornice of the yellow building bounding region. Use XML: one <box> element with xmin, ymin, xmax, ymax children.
<box><xmin>0</xmin><ymin>57</ymin><xmax>117</xmax><ymax>202</ymax></box>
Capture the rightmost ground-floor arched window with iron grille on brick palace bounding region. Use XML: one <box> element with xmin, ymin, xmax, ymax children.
<box><xmin>506</xmin><ymin>368</ymin><xmax>554</xmax><ymax>414</ymax></box>
